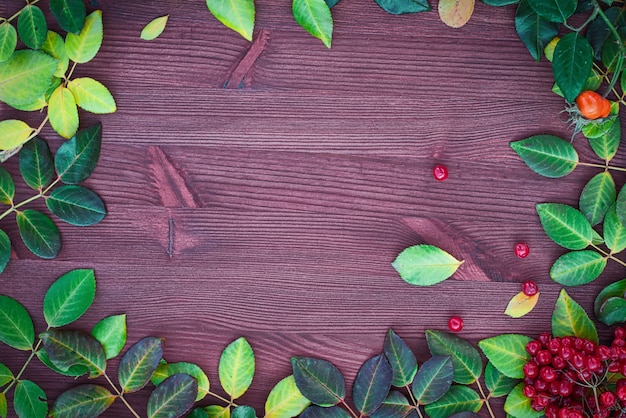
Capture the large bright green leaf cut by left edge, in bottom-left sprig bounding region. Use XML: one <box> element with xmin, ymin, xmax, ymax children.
<box><xmin>0</xmin><ymin>295</ymin><xmax>35</xmax><ymax>351</ymax></box>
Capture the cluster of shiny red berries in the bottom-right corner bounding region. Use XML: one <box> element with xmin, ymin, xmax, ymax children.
<box><xmin>524</xmin><ymin>327</ymin><xmax>626</xmax><ymax>418</ymax></box>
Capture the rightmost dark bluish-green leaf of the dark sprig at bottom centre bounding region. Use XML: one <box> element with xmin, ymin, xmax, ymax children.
<box><xmin>411</xmin><ymin>356</ymin><xmax>454</xmax><ymax>405</ymax></box>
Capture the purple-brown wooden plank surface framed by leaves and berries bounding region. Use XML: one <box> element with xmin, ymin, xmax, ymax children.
<box><xmin>0</xmin><ymin>0</ymin><xmax>626</xmax><ymax>417</ymax></box>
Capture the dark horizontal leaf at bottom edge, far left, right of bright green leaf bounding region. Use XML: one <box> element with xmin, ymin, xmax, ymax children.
<box><xmin>50</xmin><ymin>385</ymin><xmax>117</xmax><ymax>418</ymax></box>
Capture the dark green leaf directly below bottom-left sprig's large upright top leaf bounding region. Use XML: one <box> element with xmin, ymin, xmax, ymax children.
<box><xmin>39</xmin><ymin>329</ymin><xmax>106</xmax><ymax>379</ymax></box>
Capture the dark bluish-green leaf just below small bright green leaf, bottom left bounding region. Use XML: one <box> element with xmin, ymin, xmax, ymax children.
<box><xmin>118</xmin><ymin>337</ymin><xmax>163</xmax><ymax>398</ymax></box>
